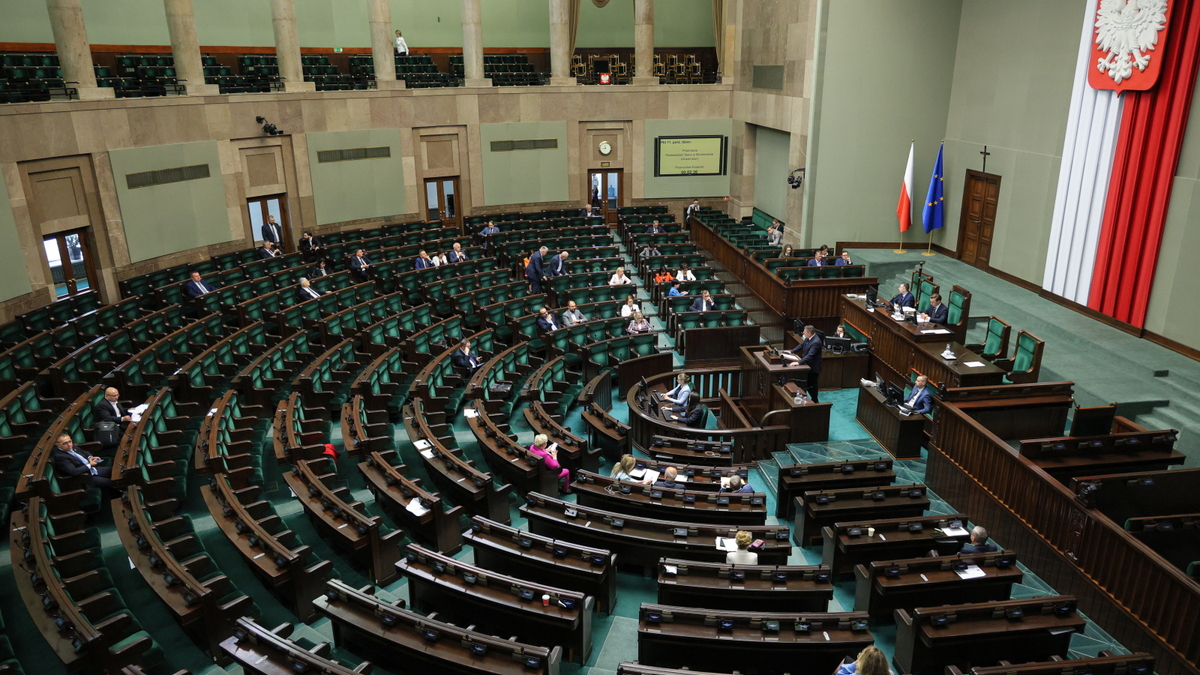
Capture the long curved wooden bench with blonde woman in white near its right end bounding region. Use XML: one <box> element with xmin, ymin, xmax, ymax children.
<box><xmin>520</xmin><ymin>492</ymin><xmax>792</xmax><ymax>569</ymax></box>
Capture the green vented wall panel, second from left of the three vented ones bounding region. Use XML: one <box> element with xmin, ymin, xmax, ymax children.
<box><xmin>307</xmin><ymin>129</ymin><xmax>409</xmax><ymax>225</ymax></box>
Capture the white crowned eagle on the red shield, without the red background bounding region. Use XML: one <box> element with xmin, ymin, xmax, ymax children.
<box><xmin>1088</xmin><ymin>0</ymin><xmax>1168</xmax><ymax>89</ymax></box>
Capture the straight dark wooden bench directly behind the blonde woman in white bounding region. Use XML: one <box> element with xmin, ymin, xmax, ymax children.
<box><xmin>659</xmin><ymin>557</ymin><xmax>833</xmax><ymax>611</ymax></box>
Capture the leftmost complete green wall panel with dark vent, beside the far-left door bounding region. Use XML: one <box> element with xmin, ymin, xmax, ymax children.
<box><xmin>108</xmin><ymin>141</ymin><xmax>233</xmax><ymax>263</ymax></box>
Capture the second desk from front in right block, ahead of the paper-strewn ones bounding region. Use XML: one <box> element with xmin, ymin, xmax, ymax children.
<box><xmin>792</xmin><ymin>485</ymin><xmax>929</xmax><ymax>546</ymax></box>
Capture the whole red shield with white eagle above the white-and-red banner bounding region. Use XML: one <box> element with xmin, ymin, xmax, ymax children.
<box><xmin>1087</xmin><ymin>0</ymin><xmax>1170</xmax><ymax>92</ymax></box>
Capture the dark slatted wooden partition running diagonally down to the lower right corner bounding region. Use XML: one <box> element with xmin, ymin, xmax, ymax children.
<box><xmin>925</xmin><ymin>401</ymin><xmax>1200</xmax><ymax>675</ymax></box>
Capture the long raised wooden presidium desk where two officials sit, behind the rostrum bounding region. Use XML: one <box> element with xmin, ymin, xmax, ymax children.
<box><xmin>841</xmin><ymin>295</ymin><xmax>1004</xmax><ymax>387</ymax></box>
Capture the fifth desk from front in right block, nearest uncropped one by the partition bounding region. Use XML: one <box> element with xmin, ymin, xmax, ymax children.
<box><xmin>893</xmin><ymin>596</ymin><xmax>1086</xmax><ymax>675</ymax></box>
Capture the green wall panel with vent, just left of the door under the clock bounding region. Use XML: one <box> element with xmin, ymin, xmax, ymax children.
<box><xmin>479</xmin><ymin>121</ymin><xmax>569</xmax><ymax>207</ymax></box>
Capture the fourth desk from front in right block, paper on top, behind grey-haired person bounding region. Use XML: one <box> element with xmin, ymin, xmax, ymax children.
<box><xmin>854</xmin><ymin>551</ymin><xmax>1025</xmax><ymax>620</ymax></box>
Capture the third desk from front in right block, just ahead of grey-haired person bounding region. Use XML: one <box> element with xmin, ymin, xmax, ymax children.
<box><xmin>821</xmin><ymin>513</ymin><xmax>971</xmax><ymax>574</ymax></box>
